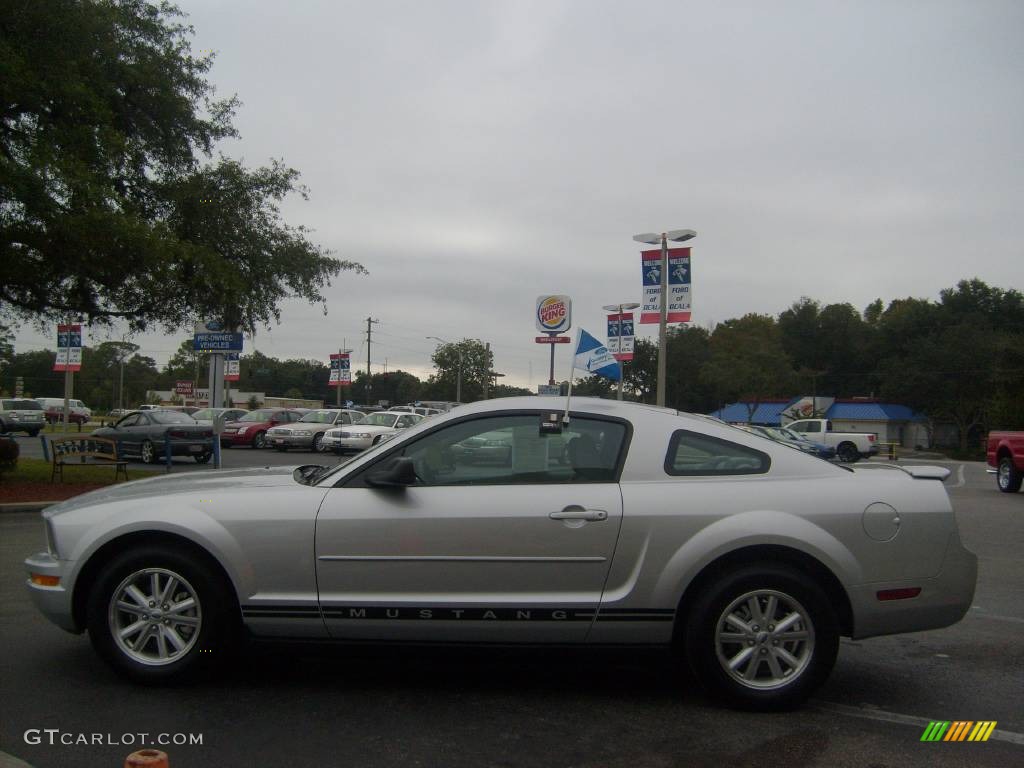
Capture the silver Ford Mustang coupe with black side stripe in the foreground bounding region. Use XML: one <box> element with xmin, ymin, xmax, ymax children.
<box><xmin>19</xmin><ymin>397</ymin><xmax>977</xmax><ymax>710</ymax></box>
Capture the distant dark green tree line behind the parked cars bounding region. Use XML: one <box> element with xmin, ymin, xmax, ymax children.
<box><xmin>0</xmin><ymin>279</ymin><xmax>1024</xmax><ymax>447</ymax></box>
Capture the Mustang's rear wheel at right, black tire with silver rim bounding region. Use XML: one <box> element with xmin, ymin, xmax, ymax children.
<box><xmin>681</xmin><ymin>562</ymin><xmax>839</xmax><ymax>712</ymax></box>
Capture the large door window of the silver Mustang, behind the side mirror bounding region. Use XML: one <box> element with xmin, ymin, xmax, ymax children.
<box><xmin>402</xmin><ymin>414</ymin><xmax>626</xmax><ymax>485</ymax></box>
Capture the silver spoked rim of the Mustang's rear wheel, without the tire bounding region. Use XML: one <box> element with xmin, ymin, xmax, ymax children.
<box><xmin>715</xmin><ymin>590</ymin><xmax>814</xmax><ymax>690</ymax></box>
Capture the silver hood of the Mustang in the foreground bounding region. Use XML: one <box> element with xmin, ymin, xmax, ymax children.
<box><xmin>43</xmin><ymin>466</ymin><xmax>296</xmax><ymax>517</ymax></box>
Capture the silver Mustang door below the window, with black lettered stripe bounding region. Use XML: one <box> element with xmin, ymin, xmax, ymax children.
<box><xmin>316</xmin><ymin>482</ymin><xmax>622</xmax><ymax>642</ymax></box>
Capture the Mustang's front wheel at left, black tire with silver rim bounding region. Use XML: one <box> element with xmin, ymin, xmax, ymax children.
<box><xmin>86</xmin><ymin>544</ymin><xmax>240</xmax><ymax>684</ymax></box>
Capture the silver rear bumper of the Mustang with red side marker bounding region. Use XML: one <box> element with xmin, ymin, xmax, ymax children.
<box><xmin>847</xmin><ymin>532</ymin><xmax>978</xmax><ymax>639</ymax></box>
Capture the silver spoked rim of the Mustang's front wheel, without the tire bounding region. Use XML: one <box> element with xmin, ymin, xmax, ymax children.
<box><xmin>108</xmin><ymin>568</ymin><xmax>203</xmax><ymax>666</ymax></box>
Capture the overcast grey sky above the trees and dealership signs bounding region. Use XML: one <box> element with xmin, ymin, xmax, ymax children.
<box><xmin>9</xmin><ymin>0</ymin><xmax>1024</xmax><ymax>388</ymax></box>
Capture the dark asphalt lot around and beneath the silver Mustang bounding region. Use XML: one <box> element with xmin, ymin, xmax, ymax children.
<box><xmin>0</xmin><ymin>460</ymin><xmax>1024</xmax><ymax>768</ymax></box>
